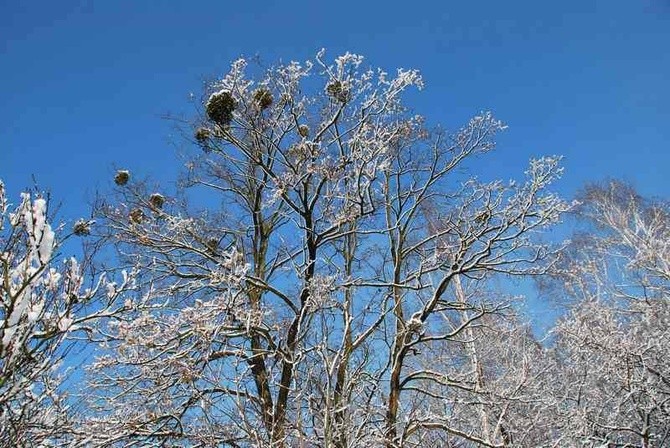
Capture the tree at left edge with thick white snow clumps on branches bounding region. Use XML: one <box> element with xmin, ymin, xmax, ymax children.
<box><xmin>0</xmin><ymin>182</ymin><xmax>129</xmax><ymax>446</ymax></box>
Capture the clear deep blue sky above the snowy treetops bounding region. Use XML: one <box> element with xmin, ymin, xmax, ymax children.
<box><xmin>0</xmin><ymin>0</ymin><xmax>670</xmax><ymax>215</ymax></box>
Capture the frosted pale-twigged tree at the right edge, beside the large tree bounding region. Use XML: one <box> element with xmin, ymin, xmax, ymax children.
<box><xmin>554</xmin><ymin>182</ymin><xmax>670</xmax><ymax>448</ymax></box>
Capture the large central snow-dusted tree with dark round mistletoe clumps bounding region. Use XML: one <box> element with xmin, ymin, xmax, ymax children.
<box><xmin>85</xmin><ymin>52</ymin><xmax>569</xmax><ymax>448</ymax></box>
